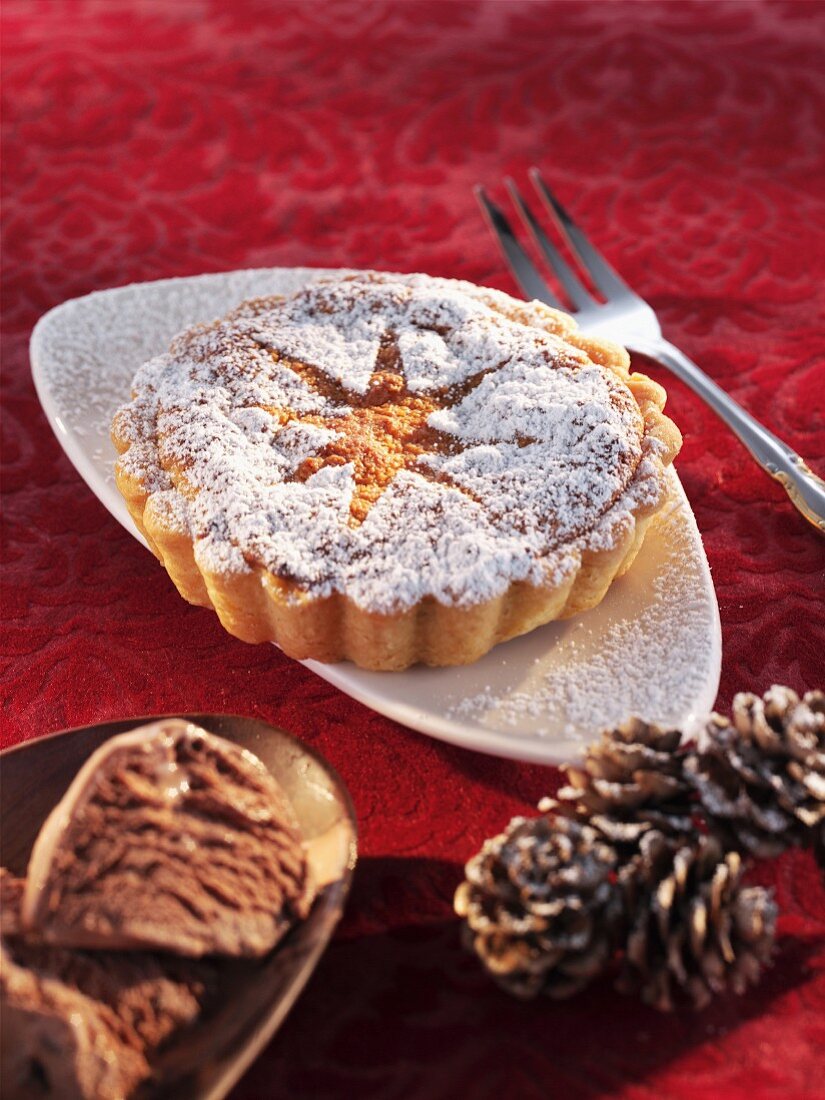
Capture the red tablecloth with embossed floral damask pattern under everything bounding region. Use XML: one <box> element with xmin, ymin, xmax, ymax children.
<box><xmin>0</xmin><ymin>0</ymin><xmax>825</xmax><ymax>1100</ymax></box>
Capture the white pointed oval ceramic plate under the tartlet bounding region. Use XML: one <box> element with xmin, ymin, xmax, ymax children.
<box><xmin>31</xmin><ymin>268</ymin><xmax>722</xmax><ymax>763</ymax></box>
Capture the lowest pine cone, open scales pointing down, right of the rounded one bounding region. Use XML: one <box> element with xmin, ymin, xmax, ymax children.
<box><xmin>618</xmin><ymin>833</ymin><xmax>777</xmax><ymax>1012</ymax></box>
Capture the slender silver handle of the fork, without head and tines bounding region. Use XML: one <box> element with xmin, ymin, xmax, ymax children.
<box><xmin>630</xmin><ymin>340</ymin><xmax>825</xmax><ymax>534</ymax></box>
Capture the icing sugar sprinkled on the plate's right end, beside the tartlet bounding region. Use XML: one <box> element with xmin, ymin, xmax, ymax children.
<box><xmin>447</xmin><ymin>492</ymin><xmax>719</xmax><ymax>746</ymax></box>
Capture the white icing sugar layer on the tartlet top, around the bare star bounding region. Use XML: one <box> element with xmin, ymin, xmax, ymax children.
<box><xmin>117</xmin><ymin>276</ymin><xmax>662</xmax><ymax>612</ymax></box>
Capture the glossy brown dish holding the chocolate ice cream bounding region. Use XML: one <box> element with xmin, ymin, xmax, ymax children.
<box><xmin>0</xmin><ymin>714</ymin><xmax>356</xmax><ymax>1100</ymax></box>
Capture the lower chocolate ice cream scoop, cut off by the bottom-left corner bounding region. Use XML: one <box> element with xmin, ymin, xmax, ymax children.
<box><xmin>0</xmin><ymin>868</ymin><xmax>215</xmax><ymax>1100</ymax></box>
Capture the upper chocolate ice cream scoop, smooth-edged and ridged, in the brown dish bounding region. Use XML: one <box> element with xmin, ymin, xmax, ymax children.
<box><xmin>22</xmin><ymin>719</ymin><xmax>311</xmax><ymax>956</ymax></box>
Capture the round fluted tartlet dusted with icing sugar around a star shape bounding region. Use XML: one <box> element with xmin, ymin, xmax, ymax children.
<box><xmin>112</xmin><ymin>273</ymin><xmax>681</xmax><ymax>670</ymax></box>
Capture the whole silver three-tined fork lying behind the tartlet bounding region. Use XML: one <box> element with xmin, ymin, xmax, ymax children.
<box><xmin>476</xmin><ymin>168</ymin><xmax>825</xmax><ymax>532</ymax></box>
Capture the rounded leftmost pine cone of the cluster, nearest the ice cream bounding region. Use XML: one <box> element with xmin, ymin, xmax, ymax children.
<box><xmin>455</xmin><ymin>817</ymin><xmax>619</xmax><ymax>998</ymax></box>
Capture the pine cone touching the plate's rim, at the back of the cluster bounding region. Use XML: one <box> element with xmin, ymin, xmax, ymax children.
<box><xmin>539</xmin><ymin>718</ymin><xmax>693</xmax><ymax>854</ymax></box>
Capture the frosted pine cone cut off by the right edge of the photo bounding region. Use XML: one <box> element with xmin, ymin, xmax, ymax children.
<box><xmin>685</xmin><ymin>685</ymin><xmax>825</xmax><ymax>858</ymax></box>
